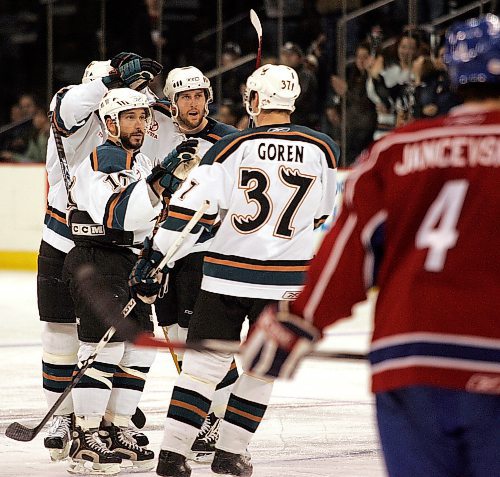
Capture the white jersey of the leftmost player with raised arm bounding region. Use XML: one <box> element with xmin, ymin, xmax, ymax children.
<box><xmin>42</xmin><ymin>81</ymin><xmax>107</xmax><ymax>253</ymax></box>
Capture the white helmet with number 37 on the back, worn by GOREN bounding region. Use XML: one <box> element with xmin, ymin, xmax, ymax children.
<box><xmin>245</xmin><ymin>65</ymin><xmax>300</xmax><ymax>116</ymax></box>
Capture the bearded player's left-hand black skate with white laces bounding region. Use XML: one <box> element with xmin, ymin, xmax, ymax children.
<box><xmin>67</xmin><ymin>427</ymin><xmax>122</xmax><ymax>475</ymax></box>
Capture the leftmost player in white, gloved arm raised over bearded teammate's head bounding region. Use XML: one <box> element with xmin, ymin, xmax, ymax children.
<box><xmin>41</xmin><ymin>52</ymin><xmax>161</xmax><ymax>460</ymax></box>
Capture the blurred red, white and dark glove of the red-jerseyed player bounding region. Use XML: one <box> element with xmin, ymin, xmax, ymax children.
<box><xmin>241</xmin><ymin>302</ymin><xmax>321</xmax><ymax>379</ymax></box>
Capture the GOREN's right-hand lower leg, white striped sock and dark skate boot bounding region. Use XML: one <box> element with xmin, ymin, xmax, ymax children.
<box><xmin>212</xmin><ymin>373</ymin><xmax>274</xmax><ymax>477</ymax></box>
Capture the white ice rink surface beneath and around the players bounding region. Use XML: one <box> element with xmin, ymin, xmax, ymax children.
<box><xmin>0</xmin><ymin>271</ymin><xmax>385</xmax><ymax>477</ymax></box>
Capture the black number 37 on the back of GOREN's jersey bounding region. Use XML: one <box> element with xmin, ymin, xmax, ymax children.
<box><xmin>231</xmin><ymin>166</ymin><xmax>316</xmax><ymax>239</ymax></box>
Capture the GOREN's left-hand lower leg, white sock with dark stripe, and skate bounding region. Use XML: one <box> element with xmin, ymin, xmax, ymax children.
<box><xmin>156</xmin><ymin>351</ymin><xmax>232</xmax><ymax>477</ymax></box>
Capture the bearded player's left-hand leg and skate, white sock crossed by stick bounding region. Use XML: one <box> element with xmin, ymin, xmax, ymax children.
<box><xmin>68</xmin><ymin>343</ymin><xmax>125</xmax><ymax>475</ymax></box>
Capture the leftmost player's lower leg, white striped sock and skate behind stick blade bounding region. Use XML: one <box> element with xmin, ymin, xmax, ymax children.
<box><xmin>42</xmin><ymin>323</ymin><xmax>78</xmax><ymax>461</ymax></box>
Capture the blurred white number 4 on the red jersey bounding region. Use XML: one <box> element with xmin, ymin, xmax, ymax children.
<box><xmin>415</xmin><ymin>180</ymin><xmax>469</xmax><ymax>272</ymax></box>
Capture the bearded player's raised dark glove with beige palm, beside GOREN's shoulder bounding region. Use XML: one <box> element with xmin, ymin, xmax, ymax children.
<box><xmin>146</xmin><ymin>139</ymin><xmax>201</xmax><ymax>197</ymax></box>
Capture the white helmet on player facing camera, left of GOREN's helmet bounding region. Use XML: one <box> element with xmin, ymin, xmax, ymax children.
<box><xmin>163</xmin><ymin>66</ymin><xmax>214</xmax><ymax>118</ymax></box>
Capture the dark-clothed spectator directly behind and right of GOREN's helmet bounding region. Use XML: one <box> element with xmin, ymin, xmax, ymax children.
<box><xmin>280</xmin><ymin>41</ymin><xmax>319</xmax><ymax>129</ymax></box>
